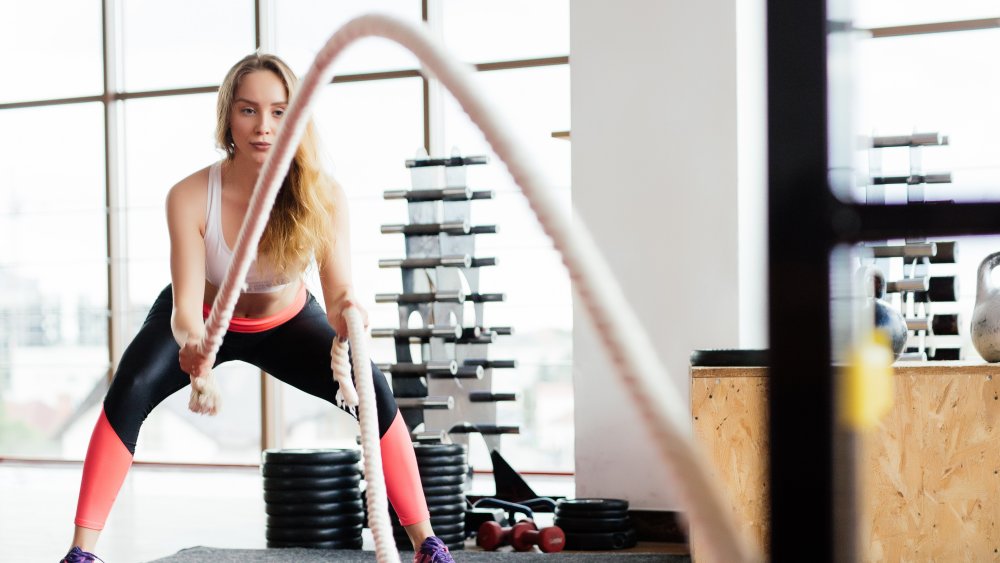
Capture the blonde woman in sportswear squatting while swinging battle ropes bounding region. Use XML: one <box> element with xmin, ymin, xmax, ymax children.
<box><xmin>64</xmin><ymin>54</ymin><xmax>452</xmax><ymax>563</ymax></box>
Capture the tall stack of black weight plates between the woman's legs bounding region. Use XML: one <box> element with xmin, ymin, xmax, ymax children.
<box><xmin>261</xmin><ymin>449</ymin><xmax>364</xmax><ymax>549</ymax></box>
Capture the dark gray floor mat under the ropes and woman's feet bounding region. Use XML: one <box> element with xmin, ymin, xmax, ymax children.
<box><xmin>151</xmin><ymin>547</ymin><xmax>691</xmax><ymax>563</ymax></box>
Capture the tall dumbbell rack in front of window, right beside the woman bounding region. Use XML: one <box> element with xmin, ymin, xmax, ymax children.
<box><xmin>372</xmin><ymin>149</ymin><xmax>520</xmax><ymax>452</ymax></box>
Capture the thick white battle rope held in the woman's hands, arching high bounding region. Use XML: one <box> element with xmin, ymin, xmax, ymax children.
<box><xmin>190</xmin><ymin>15</ymin><xmax>758</xmax><ymax>563</ymax></box>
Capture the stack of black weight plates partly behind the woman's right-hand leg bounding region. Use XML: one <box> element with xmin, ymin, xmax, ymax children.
<box><xmin>389</xmin><ymin>444</ymin><xmax>469</xmax><ymax>551</ymax></box>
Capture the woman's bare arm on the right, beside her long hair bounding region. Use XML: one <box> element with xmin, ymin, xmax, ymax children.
<box><xmin>317</xmin><ymin>182</ymin><xmax>368</xmax><ymax>338</ymax></box>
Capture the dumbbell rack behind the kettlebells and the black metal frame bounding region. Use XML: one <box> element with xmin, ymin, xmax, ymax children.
<box><xmin>865</xmin><ymin>133</ymin><xmax>961</xmax><ymax>361</ymax></box>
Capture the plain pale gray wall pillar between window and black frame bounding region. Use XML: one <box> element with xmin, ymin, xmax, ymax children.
<box><xmin>570</xmin><ymin>0</ymin><xmax>765</xmax><ymax>509</ymax></box>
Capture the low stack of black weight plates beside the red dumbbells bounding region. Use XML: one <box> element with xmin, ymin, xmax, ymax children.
<box><xmin>554</xmin><ymin>498</ymin><xmax>636</xmax><ymax>551</ymax></box>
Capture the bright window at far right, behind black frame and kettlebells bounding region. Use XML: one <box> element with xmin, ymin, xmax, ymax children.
<box><xmin>855</xmin><ymin>5</ymin><xmax>1000</xmax><ymax>359</ymax></box>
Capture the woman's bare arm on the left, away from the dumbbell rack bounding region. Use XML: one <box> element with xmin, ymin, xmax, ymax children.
<box><xmin>167</xmin><ymin>174</ymin><xmax>214</xmax><ymax>376</ymax></box>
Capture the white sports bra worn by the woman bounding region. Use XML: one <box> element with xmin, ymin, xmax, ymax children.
<box><xmin>205</xmin><ymin>161</ymin><xmax>289</xmax><ymax>293</ymax></box>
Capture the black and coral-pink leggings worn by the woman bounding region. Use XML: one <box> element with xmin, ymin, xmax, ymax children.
<box><xmin>76</xmin><ymin>286</ymin><xmax>430</xmax><ymax>530</ymax></box>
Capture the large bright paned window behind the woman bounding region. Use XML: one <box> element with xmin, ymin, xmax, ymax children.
<box><xmin>0</xmin><ymin>0</ymin><xmax>573</xmax><ymax>471</ymax></box>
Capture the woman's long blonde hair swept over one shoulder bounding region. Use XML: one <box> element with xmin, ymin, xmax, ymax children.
<box><xmin>215</xmin><ymin>53</ymin><xmax>334</xmax><ymax>278</ymax></box>
